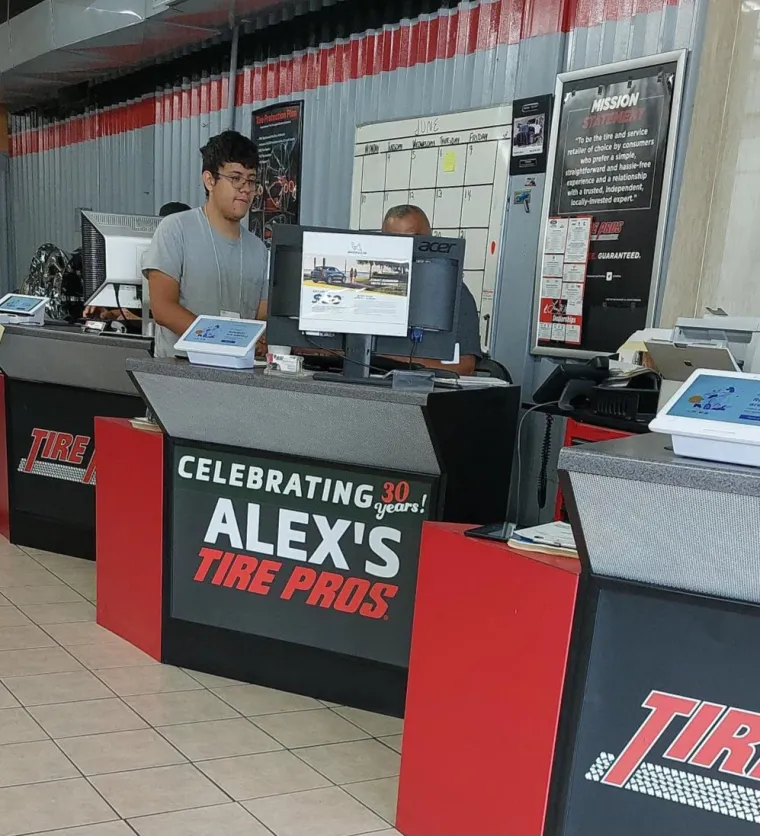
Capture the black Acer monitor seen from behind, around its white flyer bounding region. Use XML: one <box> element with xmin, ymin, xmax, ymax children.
<box><xmin>267</xmin><ymin>224</ymin><xmax>465</xmax><ymax>375</ymax></box>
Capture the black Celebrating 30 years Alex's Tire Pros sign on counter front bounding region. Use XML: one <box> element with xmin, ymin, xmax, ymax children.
<box><xmin>170</xmin><ymin>445</ymin><xmax>434</xmax><ymax>667</ymax></box>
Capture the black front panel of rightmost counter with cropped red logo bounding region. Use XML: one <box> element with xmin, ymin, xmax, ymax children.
<box><xmin>555</xmin><ymin>585</ymin><xmax>760</xmax><ymax>836</ymax></box>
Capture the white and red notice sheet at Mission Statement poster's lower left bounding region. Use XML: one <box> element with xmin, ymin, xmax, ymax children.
<box><xmin>538</xmin><ymin>216</ymin><xmax>592</xmax><ymax>345</ymax></box>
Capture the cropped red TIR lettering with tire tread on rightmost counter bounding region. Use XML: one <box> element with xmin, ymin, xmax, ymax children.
<box><xmin>585</xmin><ymin>691</ymin><xmax>760</xmax><ymax>824</ymax></box>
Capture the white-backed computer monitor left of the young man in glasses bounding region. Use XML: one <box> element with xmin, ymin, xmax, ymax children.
<box><xmin>82</xmin><ymin>210</ymin><xmax>161</xmax><ymax>330</ymax></box>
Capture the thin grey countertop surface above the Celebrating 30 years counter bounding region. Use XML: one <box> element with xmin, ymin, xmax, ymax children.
<box><xmin>127</xmin><ymin>359</ymin><xmax>476</xmax><ymax>406</ymax></box>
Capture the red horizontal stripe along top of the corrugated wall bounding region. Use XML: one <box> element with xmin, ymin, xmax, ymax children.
<box><xmin>8</xmin><ymin>0</ymin><xmax>694</xmax><ymax>156</ymax></box>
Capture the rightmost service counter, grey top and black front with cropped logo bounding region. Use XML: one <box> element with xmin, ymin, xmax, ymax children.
<box><xmin>552</xmin><ymin>434</ymin><xmax>760</xmax><ymax>836</ymax></box>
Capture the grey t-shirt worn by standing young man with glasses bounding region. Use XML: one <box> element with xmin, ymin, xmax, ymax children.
<box><xmin>143</xmin><ymin>209</ymin><xmax>269</xmax><ymax>357</ymax></box>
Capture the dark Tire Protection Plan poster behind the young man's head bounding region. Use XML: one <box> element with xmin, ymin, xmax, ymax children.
<box><xmin>248</xmin><ymin>102</ymin><xmax>303</xmax><ymax>246</ymax></box>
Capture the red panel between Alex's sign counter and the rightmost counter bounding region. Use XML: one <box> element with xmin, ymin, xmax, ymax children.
<box><xmin>396</xmin><ymin>523</ymin><xmax>580</xmax><ymax>836</ymax></box>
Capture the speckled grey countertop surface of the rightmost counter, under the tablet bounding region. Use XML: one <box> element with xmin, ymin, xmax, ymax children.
<box><xmin>559</xmin><ymin>433</ymin><xmax>760</xmax><ymax>496</ymax></box>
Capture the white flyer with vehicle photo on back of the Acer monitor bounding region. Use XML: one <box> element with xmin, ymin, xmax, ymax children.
<box><xmin>298</xmin><ymin>232</ymin><xmax>414</xmax><ymax>337</ymax></box>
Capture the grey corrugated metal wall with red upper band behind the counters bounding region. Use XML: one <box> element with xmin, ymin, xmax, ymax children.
<box><xmin>4</xmin><ymin>0</ymin><xmax>707</xmax><ymax>519</ymax></box>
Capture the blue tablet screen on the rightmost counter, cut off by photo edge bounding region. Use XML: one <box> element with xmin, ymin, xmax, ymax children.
<box><xmin>668</xmin><ymin>374</ymin><xmax>760</xmax><ymax>426</ymax></box>
